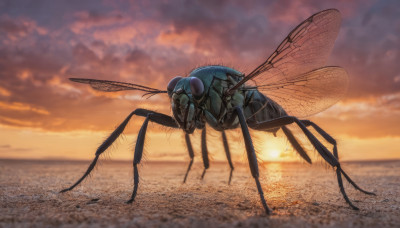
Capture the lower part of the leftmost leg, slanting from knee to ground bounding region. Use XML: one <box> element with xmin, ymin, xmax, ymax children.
<box><xmin>60</xmin><ymin>111</ymin><xmax>135</xmax><ymax>193</ymax></box>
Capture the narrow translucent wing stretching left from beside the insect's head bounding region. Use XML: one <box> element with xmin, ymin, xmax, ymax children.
<box><xmin>69</xmin><ymin>78</ymin><xmax>167</xmax><ymax>96</ymax></box>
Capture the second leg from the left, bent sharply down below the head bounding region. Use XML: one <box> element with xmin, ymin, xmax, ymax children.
<box><xmin>126</xmin><ymin>110</ymin><xmax>177</xmax><ymax>203</ymax></box>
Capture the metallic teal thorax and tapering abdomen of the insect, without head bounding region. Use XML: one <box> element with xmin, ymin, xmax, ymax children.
<box><xmin>189</xmin><ymin>66</ymin><xmax>286</xmax><ymax>130</ymax></box>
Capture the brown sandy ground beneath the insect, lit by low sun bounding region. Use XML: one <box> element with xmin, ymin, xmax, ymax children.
<box><xmin>0</xmin><ymin>160</ymin><xmax>400</xmax><ymax>227</ymax></box>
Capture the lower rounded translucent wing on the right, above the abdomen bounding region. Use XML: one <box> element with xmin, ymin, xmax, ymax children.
<box><xmin>257</xmin><ymin>67</ymin><xmax>349</xmax><ymax>117</ymax></box>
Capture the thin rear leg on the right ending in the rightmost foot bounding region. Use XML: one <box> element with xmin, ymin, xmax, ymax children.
<box><xmin>301</xmin><ymin>120</ymin><xmax>376</xmax><ymax>195</ymax></box>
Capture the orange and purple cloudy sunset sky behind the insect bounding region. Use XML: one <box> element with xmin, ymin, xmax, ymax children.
<box><xmin>0</xmin><ymin>0</ymin><xmax>400</xmax><ymax>162</ymax></box>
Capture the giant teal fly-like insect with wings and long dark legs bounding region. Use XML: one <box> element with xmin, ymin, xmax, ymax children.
<box><xmin>61</xmin><ymin>9</ymin><xmax>375</xmax><ymax>214</ymax></box>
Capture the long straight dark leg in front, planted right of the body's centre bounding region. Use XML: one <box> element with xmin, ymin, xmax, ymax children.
<box><xmin>235</xmin><ymin>107</ymin><xmax>271</xmax><ymax>214</ymax></box>
